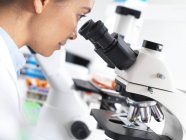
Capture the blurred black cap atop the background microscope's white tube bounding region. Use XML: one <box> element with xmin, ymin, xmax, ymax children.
<box><xmin>116</xmin><ymin>6</ymin><xmax>141</xmax><ymax>19</ymax></box>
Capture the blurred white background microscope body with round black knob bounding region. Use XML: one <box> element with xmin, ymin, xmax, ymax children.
<box><xmin>33</xmin><ymin>49</ymin><xmax>105</xmax><ymax>140</ymax></box>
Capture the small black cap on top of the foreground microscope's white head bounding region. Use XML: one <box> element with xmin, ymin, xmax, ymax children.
<box><xmin>142</xmin><ymin>40</ymin><xmax>163</xmax><ymax>52</ymax></box>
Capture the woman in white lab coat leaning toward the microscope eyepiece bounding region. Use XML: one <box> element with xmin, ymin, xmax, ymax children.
<box><xmin>0</xmin><ymin>0</ymin><xmax>93</xmax><ymax>140</ymax></box>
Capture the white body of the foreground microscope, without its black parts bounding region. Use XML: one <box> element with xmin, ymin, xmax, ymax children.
<box><xmin>115</xmin><ymin>43</ymin><xmax>186</xmax><ymax>140</ymax></box>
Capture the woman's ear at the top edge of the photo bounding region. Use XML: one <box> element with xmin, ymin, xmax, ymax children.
<box><xmin>34</xmin><ymin>0</ymin><xmax>50</xmax><ymax>14</ymax></box>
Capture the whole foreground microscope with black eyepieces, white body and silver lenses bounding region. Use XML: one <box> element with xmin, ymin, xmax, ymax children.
<box><xmin>79</xmin><ymin>20</ymin><xmax>186</xmax><ymax>140</ymax></box>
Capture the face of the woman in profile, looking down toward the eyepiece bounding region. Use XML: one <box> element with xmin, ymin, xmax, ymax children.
<box><xmin>28</xmin><ymin>0</ymin><xmax>94</xmax><ymax>56</ymax></box>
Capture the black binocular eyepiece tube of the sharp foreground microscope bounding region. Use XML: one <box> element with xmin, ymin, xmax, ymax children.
<box><xmin>79</xmin><ymin>20</ymin><xmax>137</xmax><ymax>70</ymax></box>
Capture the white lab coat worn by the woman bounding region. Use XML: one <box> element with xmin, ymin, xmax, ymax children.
<box><xmin>0</xmin><ymin>35</ymin><xmax>21</xmax><ymax>140</ymax></box>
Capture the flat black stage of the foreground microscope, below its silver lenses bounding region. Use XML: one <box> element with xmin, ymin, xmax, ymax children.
<box><xmin>91</xmin><ymin>109</ymin><xmax>171</xmax><ymax>140</ymax></box>
